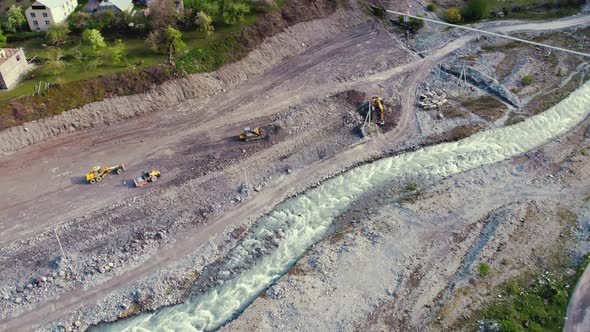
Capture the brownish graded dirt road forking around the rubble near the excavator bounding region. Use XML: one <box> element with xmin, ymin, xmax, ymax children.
<box><xmin>0</xmin><ymin>9</ymin><xmax>588</xmax><ymax>330</ymax></box>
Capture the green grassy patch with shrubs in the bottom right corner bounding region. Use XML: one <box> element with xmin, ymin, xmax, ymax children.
<box><xmin>481</xmin><ymin>255</ymin><xmax>590</xmax><ymax>331</ymax></box>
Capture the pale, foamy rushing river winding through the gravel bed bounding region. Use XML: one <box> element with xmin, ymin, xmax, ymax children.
<box><xmin>97</xmin><ymin>82</ymin><xmax>590</xmax><ymax>332</ymax></box>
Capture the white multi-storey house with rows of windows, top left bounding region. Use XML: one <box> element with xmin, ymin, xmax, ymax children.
<box><xmin>25</xmin><ymin>0</ymin><xmax>78</xmax><ymax>31</ymax></box>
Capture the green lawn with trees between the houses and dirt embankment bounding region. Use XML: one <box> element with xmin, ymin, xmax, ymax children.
<box><xmin>0</xmin><ymin>14</ymin><xmax>260</xmax><ymax>108</ymax></box>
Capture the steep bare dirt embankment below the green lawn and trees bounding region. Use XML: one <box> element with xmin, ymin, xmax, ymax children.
<box><xmin>0</xmin><ymin>0</ymin><xmax>362</xmax><ymax>156</ymax></box>
